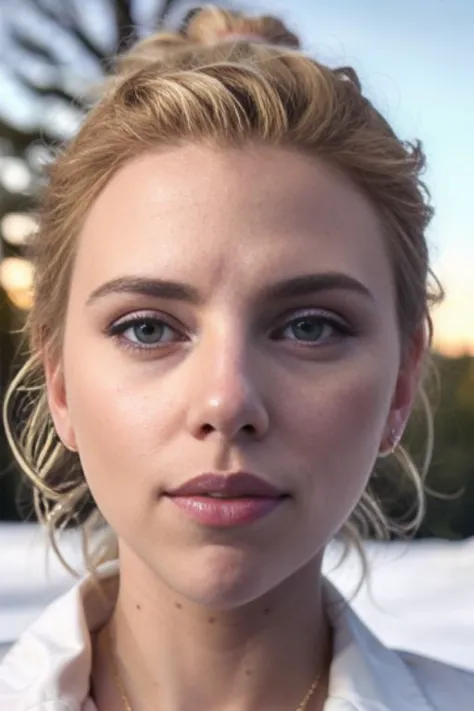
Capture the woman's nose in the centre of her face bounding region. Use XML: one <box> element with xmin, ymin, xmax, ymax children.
<box><xmin>187</xmin><ymin>338</ymin><xmax>269</xmax><ymax>441</ymax></box>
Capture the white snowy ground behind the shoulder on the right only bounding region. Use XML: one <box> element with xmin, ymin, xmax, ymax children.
<box><xmin>328</xmin><ymin>539</ymin><xmax>474</xmax><ymax>672</ymax></box>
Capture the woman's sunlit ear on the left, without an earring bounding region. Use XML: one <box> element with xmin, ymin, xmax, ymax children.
<box><xmin>43</xmin><ymin>354</ymin><xmax>77</xmax><ymax>452</ymax></box>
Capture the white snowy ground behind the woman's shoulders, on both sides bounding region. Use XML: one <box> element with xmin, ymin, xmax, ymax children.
<box><xmin>0</xmin><ymin>524</ymin><xmax>474</xmax><ymax>670</ymax></box>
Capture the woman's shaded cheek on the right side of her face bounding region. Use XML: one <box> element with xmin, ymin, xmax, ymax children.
<box><xmin>281</xmin><ymin>357</ymin><xmax>396</xmax><ymax>529</ymax></box>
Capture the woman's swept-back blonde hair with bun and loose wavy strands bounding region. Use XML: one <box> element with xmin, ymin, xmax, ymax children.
<box><xmin>4</xmin><ymin>6</ymin><xmax>441</xmax><ymax>570</ymax></box>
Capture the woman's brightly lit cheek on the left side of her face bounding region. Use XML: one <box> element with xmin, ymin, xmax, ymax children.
<box><xmin>64</xmin><ymin>341</ymin><xmax>176</xmax><ymax>522</ymax></box>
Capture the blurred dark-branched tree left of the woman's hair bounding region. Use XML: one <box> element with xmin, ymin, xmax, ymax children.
<box><xmin>0</xmin><ymin>0</ymin><xmax>194</xmax><ymax>520</ymax></box>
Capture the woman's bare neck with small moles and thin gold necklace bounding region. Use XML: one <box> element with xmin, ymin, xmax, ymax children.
<box><xmin>94</xmin><ymin>558</ymin><xmax>330</xmax><ymax>711</ymax></box>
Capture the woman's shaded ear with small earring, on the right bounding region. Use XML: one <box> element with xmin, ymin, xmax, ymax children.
<box><xmin>381</xmin><ymin>324</ymin><xmax>428</xmax><ymax>452</ymax></box>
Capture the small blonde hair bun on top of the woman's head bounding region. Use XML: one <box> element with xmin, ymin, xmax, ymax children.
<box><xmin>180</xmin><ymin>5</ymin><xmax>300</xmax><ymax>49</ymax></box>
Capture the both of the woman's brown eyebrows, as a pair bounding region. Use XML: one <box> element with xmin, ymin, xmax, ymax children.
<box><xmin>87</xmin><ymin>272</ymin><xmax>374</xmax><ymax>305</ymax></box>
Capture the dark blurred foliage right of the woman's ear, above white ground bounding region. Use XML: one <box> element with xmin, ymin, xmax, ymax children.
<box><xmin>374</xmin><ymin>354</ymin><xmax>474</xmax><ymax>540</ymax></box>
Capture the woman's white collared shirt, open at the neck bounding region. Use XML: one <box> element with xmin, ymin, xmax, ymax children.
<box><xmin>0</xmin><ymin>564</ymin><xmax>474</xmax><ymax>711</ymax></box>
